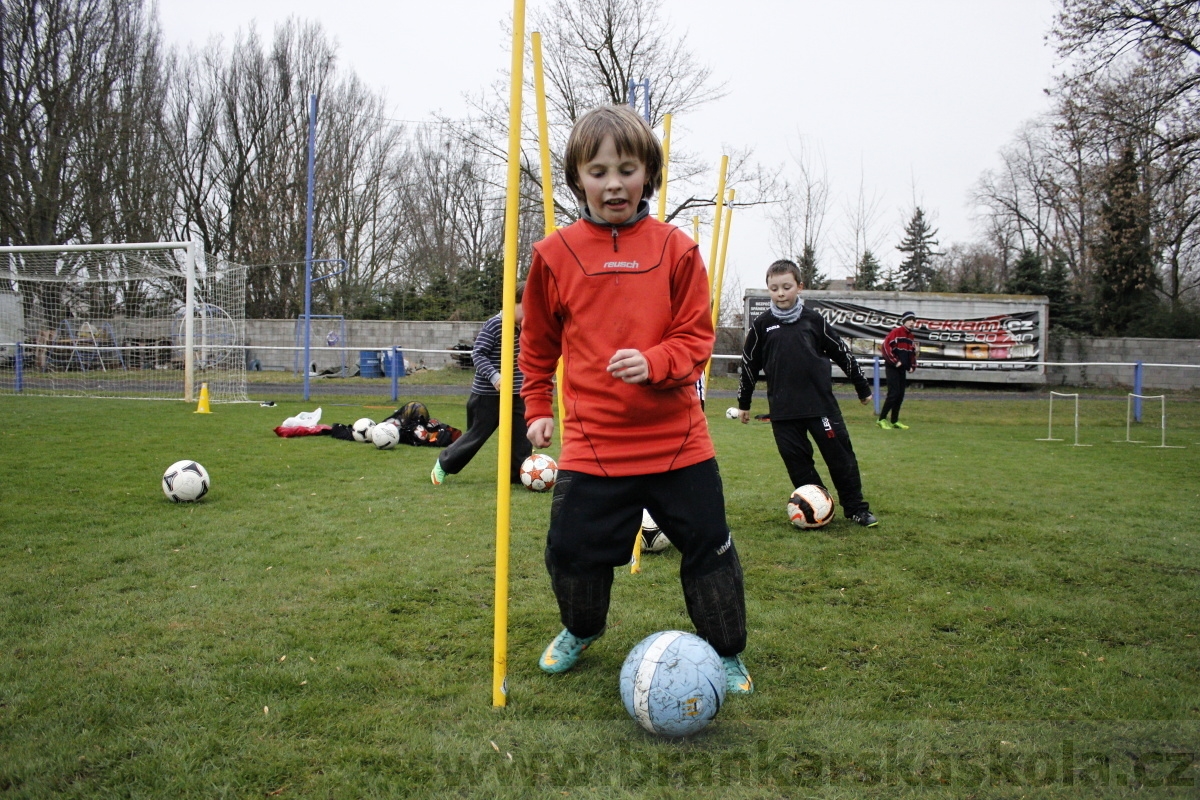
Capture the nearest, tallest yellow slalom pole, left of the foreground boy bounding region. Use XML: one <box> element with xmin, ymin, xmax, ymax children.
<box><xmin>492</xmin><ymin>0</ymin><xmax>524</xmax><ymax>705</ymax></box>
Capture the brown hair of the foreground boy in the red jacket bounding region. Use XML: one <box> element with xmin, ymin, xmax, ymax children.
<box><xmin>565</xmin><ymin>106</ymin><xmax>662</xmax><ymax>203</ymax></box>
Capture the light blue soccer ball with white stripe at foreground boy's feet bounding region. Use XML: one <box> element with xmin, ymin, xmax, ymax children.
<box><xmin>620</xmin><ymin>631</ymin><xmax>725</xmax><ymax>736</ymax></box>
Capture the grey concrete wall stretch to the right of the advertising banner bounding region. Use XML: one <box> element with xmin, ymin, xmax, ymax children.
<box><xmin>1046</xmin><ymin>337</ymin><xmax>1200</xmax><ymax>390</ymax></box>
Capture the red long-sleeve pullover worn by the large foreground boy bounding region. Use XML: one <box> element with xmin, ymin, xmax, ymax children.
<box><xmin>520</xmin><ymin>217</ymin><xmax>715</xmax><ymax>476</ymax></box>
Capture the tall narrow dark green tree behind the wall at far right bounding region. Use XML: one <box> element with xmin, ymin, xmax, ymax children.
<box><xmin>1093</xmin><ymin>146</ymin><xmax>1157</xmax><ymax>336</ymax></box>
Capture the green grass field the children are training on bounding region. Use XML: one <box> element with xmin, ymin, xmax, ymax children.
<box><xmin>0</xmin><ymin>384</ymin><xmax>1200</xmax><ymax>798</ymax></box>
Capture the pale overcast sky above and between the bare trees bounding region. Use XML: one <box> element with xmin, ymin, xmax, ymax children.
<box><xmin>158</xmin><ymin>0</ymin><xmax>1057</xmax><ymax>288</ymax></box>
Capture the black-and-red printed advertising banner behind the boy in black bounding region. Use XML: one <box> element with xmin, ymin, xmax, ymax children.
<box><xmin>748</xmin><ymin>297</ymin><xmax>1043</xmax><ymax>369</ymax></box>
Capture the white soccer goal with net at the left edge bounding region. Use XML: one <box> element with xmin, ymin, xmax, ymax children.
<box><xmin>0</xmin><ymin>242</ymin><xmax>247</xmax><ymax>403</ymax></box>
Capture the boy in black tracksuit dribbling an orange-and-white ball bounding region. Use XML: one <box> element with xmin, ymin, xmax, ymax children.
<box><xmin>738</xmin><ymin>260</ymin><xmax>878</xmax><ymax>528</ymax></box>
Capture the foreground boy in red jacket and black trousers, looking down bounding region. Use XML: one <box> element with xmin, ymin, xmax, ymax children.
<box><xmin>520</xmin><ymin>106</ymin><xmax>754</xmax><ymax>693</ymax></box>
